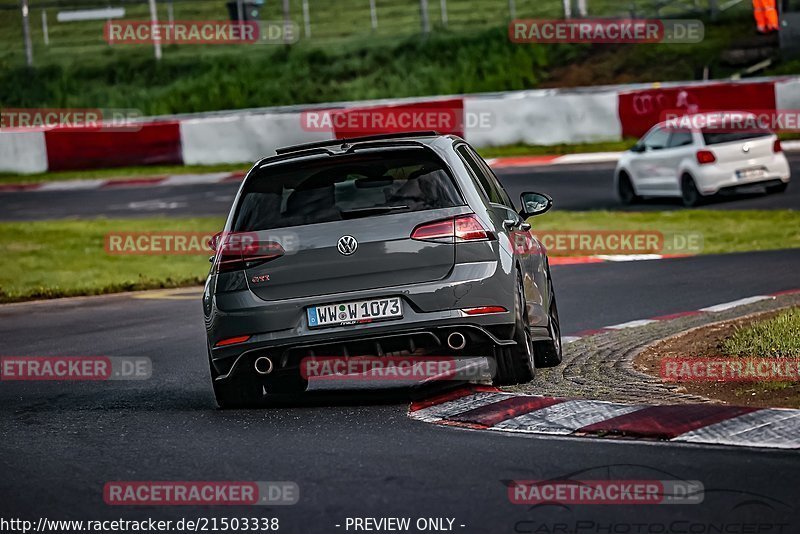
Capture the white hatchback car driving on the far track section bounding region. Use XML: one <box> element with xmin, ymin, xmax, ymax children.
<box><xmin>614</xmin><ymin>113</ymin><xmax>791</xmax><ymax>206</ymax></box>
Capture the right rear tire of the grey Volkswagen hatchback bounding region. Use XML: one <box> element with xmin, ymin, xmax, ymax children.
<box><xmin>492</xmin><ymin>281</ymin><xmax>536</xmax><ymax>386</ymax></box>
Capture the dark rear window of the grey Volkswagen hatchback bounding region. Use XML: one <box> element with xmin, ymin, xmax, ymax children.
<box><xmin>233</xmin><ymin>149</ymin><xmax>464</xmax><ymax>232</ymax></box>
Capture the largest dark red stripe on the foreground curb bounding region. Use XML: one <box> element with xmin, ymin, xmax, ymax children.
<box><xmin>578</xmin><ymin>404</ymin><xmax>757</xmax><ymax>439</ymax></box>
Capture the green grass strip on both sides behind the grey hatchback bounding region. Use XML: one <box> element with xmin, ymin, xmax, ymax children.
<box><xmin>0</xmin><ymin>210</ymin><xmax>800</xmax><ymax>302</ymax></box>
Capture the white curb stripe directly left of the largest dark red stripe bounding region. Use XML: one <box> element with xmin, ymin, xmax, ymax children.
<box><xmin>495</xmin><ymin>399</ymin><xmax>642</xmax><ymax>435</ymax></box>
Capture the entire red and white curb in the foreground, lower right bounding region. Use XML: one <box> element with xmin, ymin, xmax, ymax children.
<box><xmin>408</xmin><ymin>386</ymin><xmax>800</xmax><ymax>449</ymax></box>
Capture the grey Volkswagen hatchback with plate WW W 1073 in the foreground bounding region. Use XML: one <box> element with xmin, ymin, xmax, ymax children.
<box><xmin>203</xmin><ymin>132</ymin><xmax>561</xmax><ymax>408</ymax></box>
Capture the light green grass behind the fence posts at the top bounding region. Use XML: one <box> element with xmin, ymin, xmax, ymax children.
<box><xmin>0</xmin><ymin>0</ymin><xmax>732</xmax><ymax>64</ymax></box>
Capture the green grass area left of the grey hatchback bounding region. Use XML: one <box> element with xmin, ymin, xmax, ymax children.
<box><xmin>0</xmin><ymin>217</ymin><xmax>225</xmax><ymax>302</ymax></box>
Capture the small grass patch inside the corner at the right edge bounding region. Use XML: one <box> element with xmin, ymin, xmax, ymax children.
<box><xmin>722</xmin><ymin>308</ymin><xmax>800</xmax><ymax>358</ymax></box>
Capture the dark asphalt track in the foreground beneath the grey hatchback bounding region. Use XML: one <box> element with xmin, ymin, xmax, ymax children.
<box><xmin>0</xmin><ymin>250</ymin><xmax>800</xmax><ymax>534</ymax></box>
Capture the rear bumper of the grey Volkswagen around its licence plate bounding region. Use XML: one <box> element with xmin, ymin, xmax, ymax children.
<box><xmin>206</xmin><ymin>261</ymin><xmax>547</xmax><ymax>376</ymax></box>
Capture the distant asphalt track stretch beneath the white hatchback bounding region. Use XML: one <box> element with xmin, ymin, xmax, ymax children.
<box><xmin>0</xmin><ymin>154</ymin><xmax>800</xmax><ymax>221</ymax></box>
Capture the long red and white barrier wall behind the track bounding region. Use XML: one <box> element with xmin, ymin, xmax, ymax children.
<box><xmin>0</xmin><ymin>78</ymin><xmax>800</xmax><ymax>173</ymax></box>
